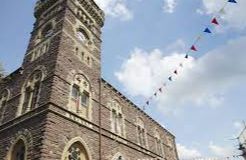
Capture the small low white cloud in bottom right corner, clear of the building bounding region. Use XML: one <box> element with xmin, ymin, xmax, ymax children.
<box><xmin>208</xmin><ymin>142</ymin><xmax>234</xmax><ymax>157</ymax></box>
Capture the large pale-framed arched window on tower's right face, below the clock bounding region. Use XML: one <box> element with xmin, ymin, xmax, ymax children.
<box><xmin>68</xmin><ymin>75</ymin><xmax>91</xmax><ymax>119</ymax></box>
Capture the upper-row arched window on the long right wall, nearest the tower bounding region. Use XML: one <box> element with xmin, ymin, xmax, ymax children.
<box><xmin>109</xmin><ymin>100</ymin><xmax>125</xmax><ymax>136</ymax></box>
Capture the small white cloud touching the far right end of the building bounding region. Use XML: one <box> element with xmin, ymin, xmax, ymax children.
<box><xmin>177</xmin><ymin>144</ymin><xmax>202</xmax><ymax>159</ymax></box>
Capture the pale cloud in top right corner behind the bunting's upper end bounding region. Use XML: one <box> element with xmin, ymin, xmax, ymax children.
<box><xmin>197</xmin><ymin>0</ymin><xmax>246</xmax><ymax>30</ymax></box>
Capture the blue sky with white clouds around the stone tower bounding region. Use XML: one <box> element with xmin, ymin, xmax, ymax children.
<box><xmin>0</xmin><ymin>0</ymin><xmax>246</xmax><ymax>159</ymax></box>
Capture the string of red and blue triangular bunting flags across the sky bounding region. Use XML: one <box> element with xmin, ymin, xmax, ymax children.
<box><xmin>143</xmin><ymin>0</ymin><xmax>237</xmax><ymax>110</ymax></box>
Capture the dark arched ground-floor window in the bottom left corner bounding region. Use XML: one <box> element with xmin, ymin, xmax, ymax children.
<box><xmin>10</xmin><ymin>139</ymin><xmax>27</xmax><ymax>160</ymax></box>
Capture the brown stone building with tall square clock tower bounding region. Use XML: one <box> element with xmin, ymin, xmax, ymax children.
<box><xmin>0</xmin><ymin>0</ymin><xmax>178</xmax><ymax>160</ymax></box>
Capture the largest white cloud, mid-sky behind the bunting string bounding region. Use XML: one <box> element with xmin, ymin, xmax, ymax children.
<box><xmin>115</xmin><ymin>37</ymin><xmax>246</xmax><ymax>113</ymax></box>
